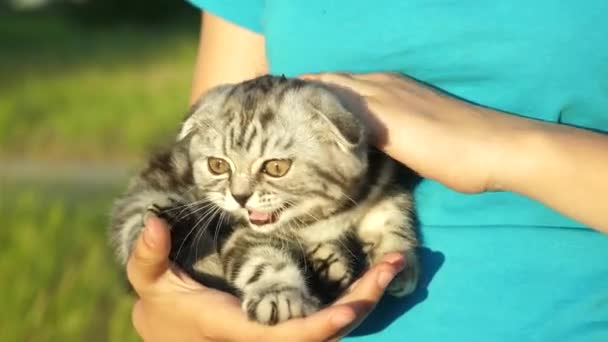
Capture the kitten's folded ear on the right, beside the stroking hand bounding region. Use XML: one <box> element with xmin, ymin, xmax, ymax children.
<box><xmin>307</xmin><ymin>88</ymin><xmax>366</xmax><ymax>151</ymax></box>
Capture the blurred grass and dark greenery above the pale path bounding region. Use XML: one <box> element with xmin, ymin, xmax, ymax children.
<box><xmin>0</xmin><ymin>11</ymin><xmax>197</xmax><ymax>159</ymax></box>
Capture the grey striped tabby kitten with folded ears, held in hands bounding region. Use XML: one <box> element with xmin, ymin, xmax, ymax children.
<box><xmin>112</xmin><ymin>76</ymin><xmax>419</xmax><ymax>324</ymax></box>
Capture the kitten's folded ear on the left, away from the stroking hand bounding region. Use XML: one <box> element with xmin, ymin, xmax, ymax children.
<box><xmin>177</xmin><ymin>84</ymin><xmax>234</xmax><ymax>141</ymax></box>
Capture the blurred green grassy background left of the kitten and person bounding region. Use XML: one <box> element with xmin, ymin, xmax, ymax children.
<box><xmin>0</xmin><ymin>0</ymin><xmax>200</xmax><ymax>342</ymax></box>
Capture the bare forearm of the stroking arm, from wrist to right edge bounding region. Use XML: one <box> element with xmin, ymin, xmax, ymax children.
<box><xmin>493</xmin><ymin>118</ymin><xmax>608</xmax><ymax>232</ymax></box>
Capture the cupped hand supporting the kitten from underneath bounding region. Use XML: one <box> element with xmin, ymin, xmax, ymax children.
<box><xmin>127</xmin><ymin>217</ymin><xmax>404</xmax><ymax>342</ymax></box>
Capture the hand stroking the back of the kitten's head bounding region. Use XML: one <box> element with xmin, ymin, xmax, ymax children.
<box><xmin>301</xmin><ymin>73</ymin><xmax>530</xmax><ymax>193</ymax></box>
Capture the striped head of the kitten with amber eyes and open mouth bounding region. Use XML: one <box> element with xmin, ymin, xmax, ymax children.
<box><xmin>178</xmin><ymin>76</ymin><xmax>367</xmax><ymax>232</ymax></box>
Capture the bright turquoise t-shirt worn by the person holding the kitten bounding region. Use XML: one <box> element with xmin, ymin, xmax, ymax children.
<box><xmin>191</xmin><ymin>0</ymin><xmax>608</xmax><ymax>342</ymax></box>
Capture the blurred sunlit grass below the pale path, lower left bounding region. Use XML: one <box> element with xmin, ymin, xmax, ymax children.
<box><xmin>0</xmin><ymin>184</ymin><xmax>137</xmax><ymax>341</ymax></box>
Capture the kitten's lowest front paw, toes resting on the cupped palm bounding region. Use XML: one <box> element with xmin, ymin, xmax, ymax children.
<box><xmin>242</xmin><ymin>287</ymin><xmax>321</xmax><ymax>325</ymax></box>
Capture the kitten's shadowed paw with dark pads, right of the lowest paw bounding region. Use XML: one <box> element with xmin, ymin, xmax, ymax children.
<box><xmin>308</xmin><ymin>244</ymin><xmax>355</xmax><ymax>290</ymax></box>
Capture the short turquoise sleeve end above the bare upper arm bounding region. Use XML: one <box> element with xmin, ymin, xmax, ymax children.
<box><xmin>187</xmin><ymin>0</ymin><xmax>264</xmax><ymax>33</ymax></box>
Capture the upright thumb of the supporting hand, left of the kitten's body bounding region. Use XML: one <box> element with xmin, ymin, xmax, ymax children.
<box><xmin>127</xmin><ymin>216</ymin><xmax>171</xmax><ymax>295</ymax></box>
